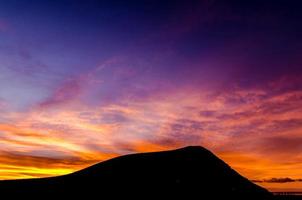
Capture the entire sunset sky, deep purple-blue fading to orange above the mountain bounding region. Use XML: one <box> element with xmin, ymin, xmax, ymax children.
<box><xmin>0</xmin><ymin>0</ymin><xmax>302</xmax><ymax>190</ymax></box>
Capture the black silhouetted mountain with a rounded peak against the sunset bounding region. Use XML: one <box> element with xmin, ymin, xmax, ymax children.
<box><xmin>0</xmin><ymin>146</ymin><xmax>271</xmax><ymax>200</ymax></box>
